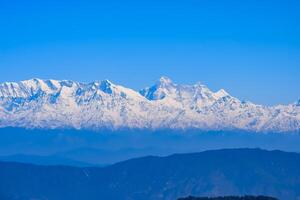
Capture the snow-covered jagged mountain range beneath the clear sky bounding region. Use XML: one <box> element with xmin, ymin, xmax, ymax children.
<box><xmin>0</xmin><ymin>77</ymin><xmax>300</xmax><ymax>132</ymax></box>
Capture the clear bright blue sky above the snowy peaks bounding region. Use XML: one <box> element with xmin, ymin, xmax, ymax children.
<box><xmin>0</xmin><ymin>0</ymin><xmax>300</xmax><ymax>105</ymax></box>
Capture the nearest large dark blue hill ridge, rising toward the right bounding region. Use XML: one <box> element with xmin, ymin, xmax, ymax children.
<box><xmin>0</xmin><ymin>149</ymin><xmax>300</xmax><ymax>200</ymax></box>
